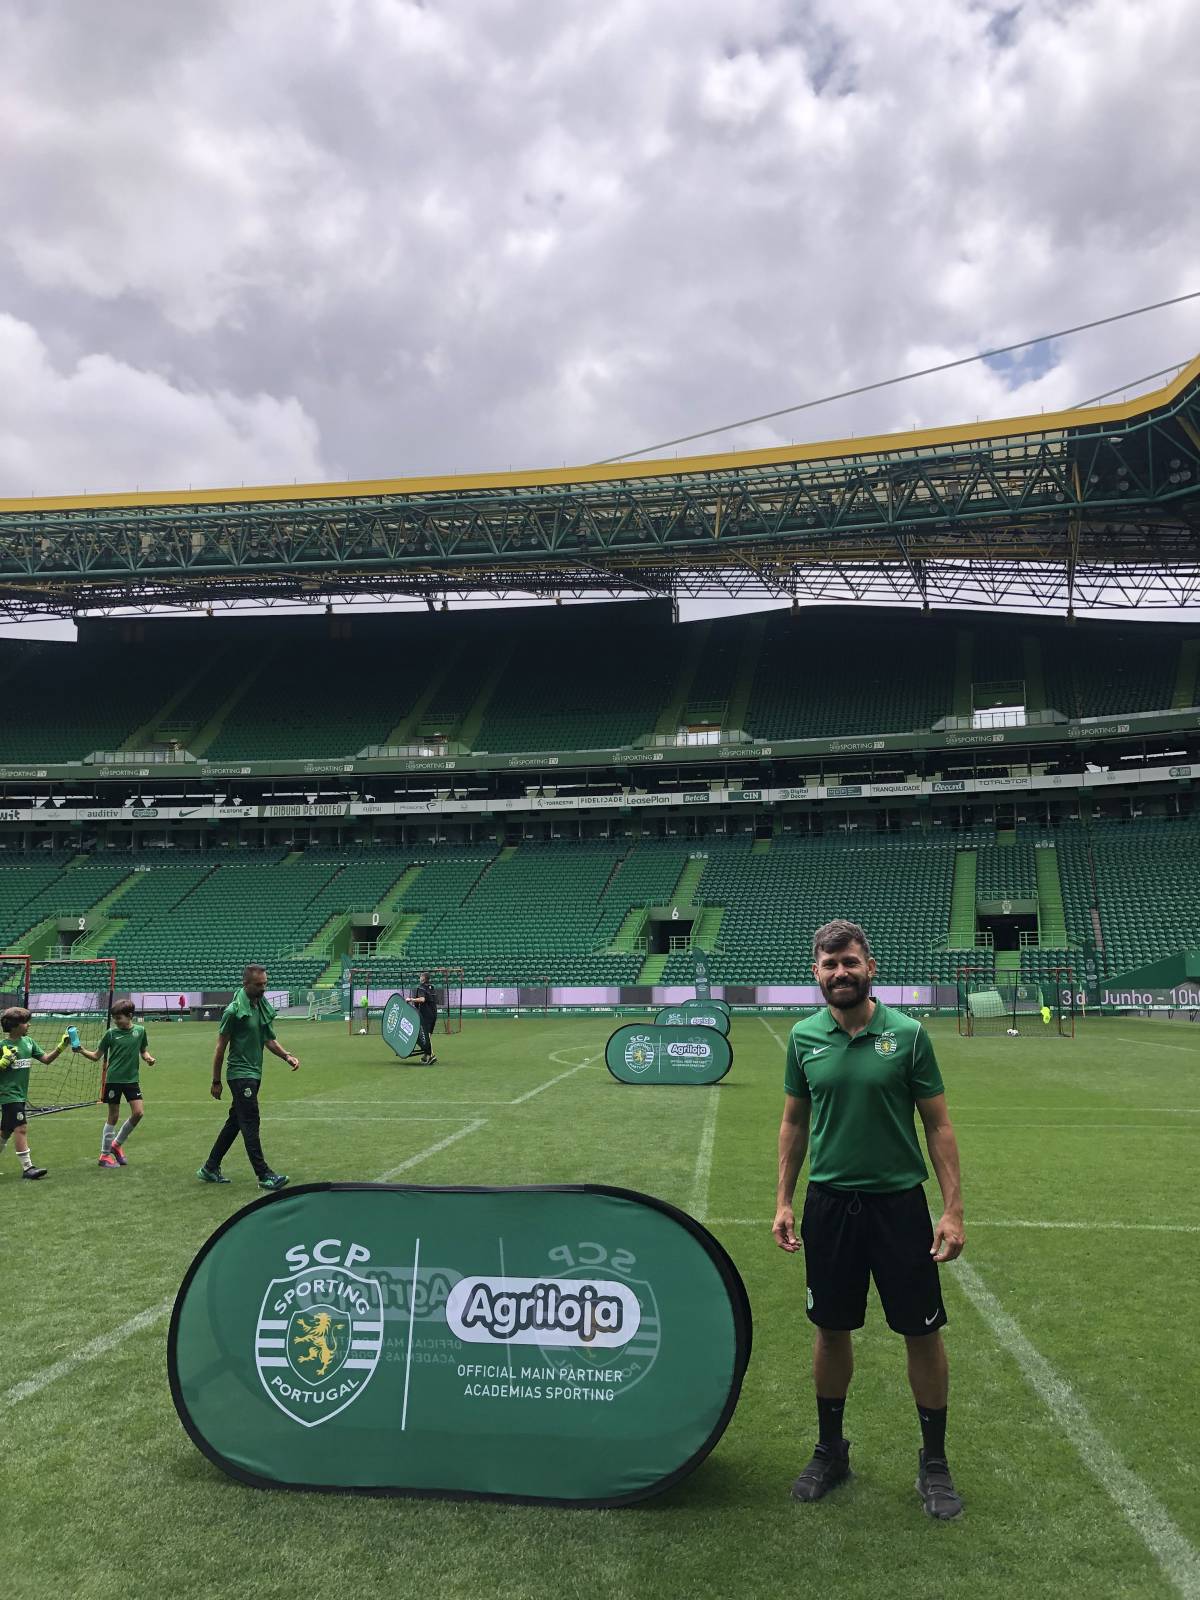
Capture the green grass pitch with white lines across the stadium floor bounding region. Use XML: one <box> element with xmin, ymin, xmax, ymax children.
<box><xmin>0</xmin><ymin>1018</ymin><xmax>1200</xmax><ymax>1600</ymax></box>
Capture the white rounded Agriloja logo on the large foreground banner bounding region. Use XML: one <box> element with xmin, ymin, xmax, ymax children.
<box><xmin>446</xmin><ymin>1277</ymin><xmax>642</xmax><ymax>1350</ymax></box>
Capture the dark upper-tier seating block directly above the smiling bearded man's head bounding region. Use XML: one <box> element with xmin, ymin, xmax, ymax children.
<box><xmin>747</xmin><ymin>606</ymin><xmax>955</xmax><ymax>739</ymax></box>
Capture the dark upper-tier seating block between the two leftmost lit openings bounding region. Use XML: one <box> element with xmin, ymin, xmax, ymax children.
<box><xmin>206</xmin><ymin>638</ymin><xmax>427</xmax><ymax>762</ymax></box>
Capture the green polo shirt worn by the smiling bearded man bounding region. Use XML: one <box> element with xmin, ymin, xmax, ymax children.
<box><xmin>784</xmin><ymin>1002</ymin><xmax>944</xmax><ymax>1194</ymax></box>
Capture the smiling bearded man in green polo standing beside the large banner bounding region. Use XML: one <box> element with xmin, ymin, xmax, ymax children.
<box><xmin>773</xmin><ymin>920</ymin><xmax>963</xmax><ymax>1520</ymax></box>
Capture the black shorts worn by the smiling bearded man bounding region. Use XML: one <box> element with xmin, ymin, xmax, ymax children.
<box><xmin>800</xmin><ymin>1184</ymin><xmax>946</xmax><ymax>1336</ymax></box>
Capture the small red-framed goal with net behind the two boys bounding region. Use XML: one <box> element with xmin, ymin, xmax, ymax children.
<box><xmin>26</xmin><ymin>957</ymin><xmax>117</xmax><ymax>1115</ymax></box>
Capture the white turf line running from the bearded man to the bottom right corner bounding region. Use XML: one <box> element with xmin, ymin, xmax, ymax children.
<box><xmin>954</xmin><ymin>1261</ymin><xmax>1200</xmax><ymax>1600</ymax></box>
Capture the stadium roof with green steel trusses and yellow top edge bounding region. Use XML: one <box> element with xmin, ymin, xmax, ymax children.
<box><xmin>0</xmin><ymin>358</ymin><xmax>1200</xmax><ymax>616</ymax></box>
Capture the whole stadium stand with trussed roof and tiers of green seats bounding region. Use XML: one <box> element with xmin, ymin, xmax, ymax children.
<box><xmin>0</xmin><ymin>362</ymin><xmax>1200</xmax><ymax>1005</ymax></box>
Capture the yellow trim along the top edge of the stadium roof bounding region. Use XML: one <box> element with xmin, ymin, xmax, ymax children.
<box><xmin>0</xmin><ymin>355</ymin><xmax>1200</xmax><ymax>514</ymax></box>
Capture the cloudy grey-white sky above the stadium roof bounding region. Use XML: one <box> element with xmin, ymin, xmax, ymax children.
<box><xmin>0</xmin><ymin>0</ymin><xmax>1200</xmax><ymax>496</ymax></box>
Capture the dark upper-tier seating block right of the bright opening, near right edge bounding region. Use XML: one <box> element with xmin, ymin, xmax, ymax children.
<box><xmin>1042</xmin><ymin>627</ymin><xmax>1179</xmax><ymax>717</ymax></box>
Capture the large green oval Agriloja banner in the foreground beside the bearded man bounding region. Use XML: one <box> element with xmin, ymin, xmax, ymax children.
<box><xmin>166</xmin><ymin>1184</ymin><xmax>750</xmax><ymax>1506</ymax></box>
